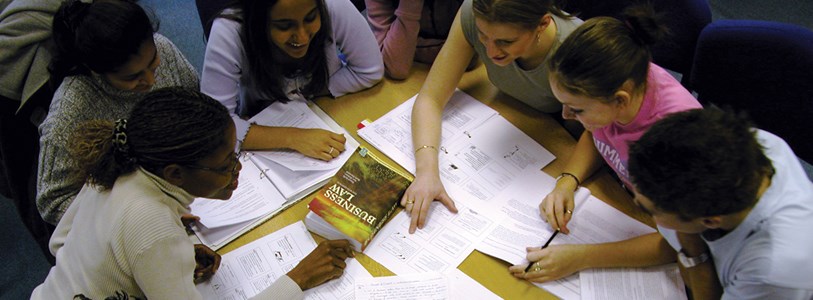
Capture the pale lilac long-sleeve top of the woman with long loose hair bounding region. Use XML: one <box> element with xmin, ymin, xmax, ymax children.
<box><xmin>200</xmin><ymin>0</ymin><xmax>384</xmax><ymax>142</ymax></box>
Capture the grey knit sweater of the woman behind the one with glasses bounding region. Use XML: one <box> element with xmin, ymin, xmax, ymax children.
<box><xmin>37</xmin><ymin>33</ymin><xmax>199</xmax><ymax>224</ymax></box>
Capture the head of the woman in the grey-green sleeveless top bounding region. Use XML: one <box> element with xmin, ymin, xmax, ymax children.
<box><xmin>472</xmin><ymin>0</ymin><xmax>568</xmax><ymax>68</ymax></box>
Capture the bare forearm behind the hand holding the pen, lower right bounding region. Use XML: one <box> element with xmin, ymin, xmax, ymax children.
<box><xmin>580</xmin><ymin>233</ymin><xmax>676</xmax><ymax>269</ymax></box>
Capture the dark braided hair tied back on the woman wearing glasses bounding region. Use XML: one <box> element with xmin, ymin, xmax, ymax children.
<box><xmin>68</xmin><ymin>87</ymin><xmax>232</xmax><ymax>189</ymax></box>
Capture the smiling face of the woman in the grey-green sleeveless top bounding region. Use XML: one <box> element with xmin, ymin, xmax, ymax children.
<box><xmin>474</xmin><ymin>18</ymin><xmax>544</xmax><ymax>66</ymax></box>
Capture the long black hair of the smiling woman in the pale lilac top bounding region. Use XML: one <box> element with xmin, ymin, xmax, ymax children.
<box><xmin>218</xmin><ymin>0</ymin><xmax>333</xmax><ymax>111</ymax></box>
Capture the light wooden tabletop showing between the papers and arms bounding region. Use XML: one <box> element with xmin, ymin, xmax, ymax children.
<box><xmin>218</xmin><ymin>64</ymin><xmax>654</xmax><ymax>299</ymax></box>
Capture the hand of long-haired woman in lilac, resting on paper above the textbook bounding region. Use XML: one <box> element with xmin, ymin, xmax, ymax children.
<box><xmin>288</xmin><ymin>128</ymin><xmax>347</xmax><ymax>161</ymax></box>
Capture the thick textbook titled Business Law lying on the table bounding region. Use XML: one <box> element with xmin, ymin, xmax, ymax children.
<box><xmin>305</xmin><ymin>148</ymin><xmax>412</xmax><ymax>251</ymax></box>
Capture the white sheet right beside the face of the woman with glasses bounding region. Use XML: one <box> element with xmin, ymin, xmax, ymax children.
<box><xmin>190</xmin><ymin>154</ymin><xmax>286</xmax><ymax>229</ymax></box>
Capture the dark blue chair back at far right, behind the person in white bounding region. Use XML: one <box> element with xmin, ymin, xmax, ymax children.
<box><xmin>691</xmin><ymin>20</ymin><xmax>813</xmax><ymax>162</ymax></box>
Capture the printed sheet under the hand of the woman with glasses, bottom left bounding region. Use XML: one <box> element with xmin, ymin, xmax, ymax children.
<box><xmin>197</xmin><ymin>221</ymin><xmax>371</xmax><ymax>300</ymax></box>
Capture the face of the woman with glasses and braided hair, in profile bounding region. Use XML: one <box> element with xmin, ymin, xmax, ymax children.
<box><xmin>181</xmin><ymin>122</ymin><xmax>243</xmax><ymax>200</ymax></box>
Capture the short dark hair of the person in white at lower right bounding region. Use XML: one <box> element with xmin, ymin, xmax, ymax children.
<box><xmin>628</xmin><ymin>108</ymin><xmax>774</xmax><ymax>220</ymax></box>
